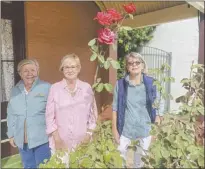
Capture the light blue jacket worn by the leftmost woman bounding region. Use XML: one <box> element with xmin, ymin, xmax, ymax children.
<box><xmin>7</xmin><ymin>78</ymin><xmax>51</xmax><ymax>148</ymax></box>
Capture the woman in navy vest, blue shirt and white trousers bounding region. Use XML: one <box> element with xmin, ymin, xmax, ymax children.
<box><xmin>112</xmin><ymin>52</ymin><xmax>163</xmax><ymax>168</ymax></box>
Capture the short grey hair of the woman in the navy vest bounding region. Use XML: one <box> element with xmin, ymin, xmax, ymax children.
<box><xmin>125</xmin><ymin>52</ymin><xmax>148</xmax><ymax>74</ymax></box>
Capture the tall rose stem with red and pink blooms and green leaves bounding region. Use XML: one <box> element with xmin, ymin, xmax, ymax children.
<box><xmin>88</xmin><ymin>3</ymin><xmax>136</xmax><ymax>92</ymax></box>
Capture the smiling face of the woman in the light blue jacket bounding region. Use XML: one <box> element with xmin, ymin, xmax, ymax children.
<box><xmin>19</xmin><ymin>64</ymin><xmax>38</xmax><ymax>85</ymax></box>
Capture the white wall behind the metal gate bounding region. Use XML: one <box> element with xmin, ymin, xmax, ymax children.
<box><xmin>147</xmin><ymin>18</ymin><xmax>199</xmax><ymax>110</ymax></box>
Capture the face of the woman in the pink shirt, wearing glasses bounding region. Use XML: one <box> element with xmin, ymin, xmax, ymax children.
<box><xmin>63</xmin><ymin>59</ymin><xmax>80</xmax><ymax>80</ymax></box>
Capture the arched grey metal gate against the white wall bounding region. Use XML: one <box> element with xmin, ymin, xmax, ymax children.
<box><xmin>137</xmin><ymin>46</ymin><xmax>172</xmax><ymax>111</ymax></box>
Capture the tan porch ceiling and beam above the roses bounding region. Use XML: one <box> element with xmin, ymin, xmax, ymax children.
<box><xmin>95</xmin><ymin>1</ymin><xmax>198</xmax><ymax>27</ymax></box>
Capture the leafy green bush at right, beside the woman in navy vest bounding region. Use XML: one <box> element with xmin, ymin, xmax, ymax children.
<box><xmin>143</xmin><ymin>64</ymin><xmax>204</xmax><ymax>168</ymax></box>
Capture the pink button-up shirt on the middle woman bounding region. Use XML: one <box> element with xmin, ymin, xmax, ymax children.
<box><xmin>46</xmin><ymin>79</ymin><xmax>97</xmax><ymax>150</ymax></box>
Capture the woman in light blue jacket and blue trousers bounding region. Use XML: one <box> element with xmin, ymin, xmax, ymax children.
<box><xmin>7</xmin><ymin>59</ymin><xmax>51</xmax><ymax>168</ymax></box>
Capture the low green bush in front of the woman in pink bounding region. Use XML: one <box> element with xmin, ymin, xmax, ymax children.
<box><xmin>40</xmin><ymin>121</ymin><xmax>123</xmax><ymax>168</ymax></box>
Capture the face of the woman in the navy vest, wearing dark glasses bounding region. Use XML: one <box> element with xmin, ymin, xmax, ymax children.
<box><xmin>127</xmin><ymin>57</ymin><xmax>144</xmax><ymax>75</ymax></box>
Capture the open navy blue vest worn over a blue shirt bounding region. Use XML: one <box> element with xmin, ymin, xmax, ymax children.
<box><xmin>117</xmin><ymin>74</ymin><xmax>157</xmax><ymax>135</ymax></box>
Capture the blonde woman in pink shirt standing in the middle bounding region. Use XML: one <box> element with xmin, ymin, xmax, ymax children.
<box><xmin>46</xmin><ymin>54</ymin><xmax>98</xmax><ymax>150</ymax></box>
